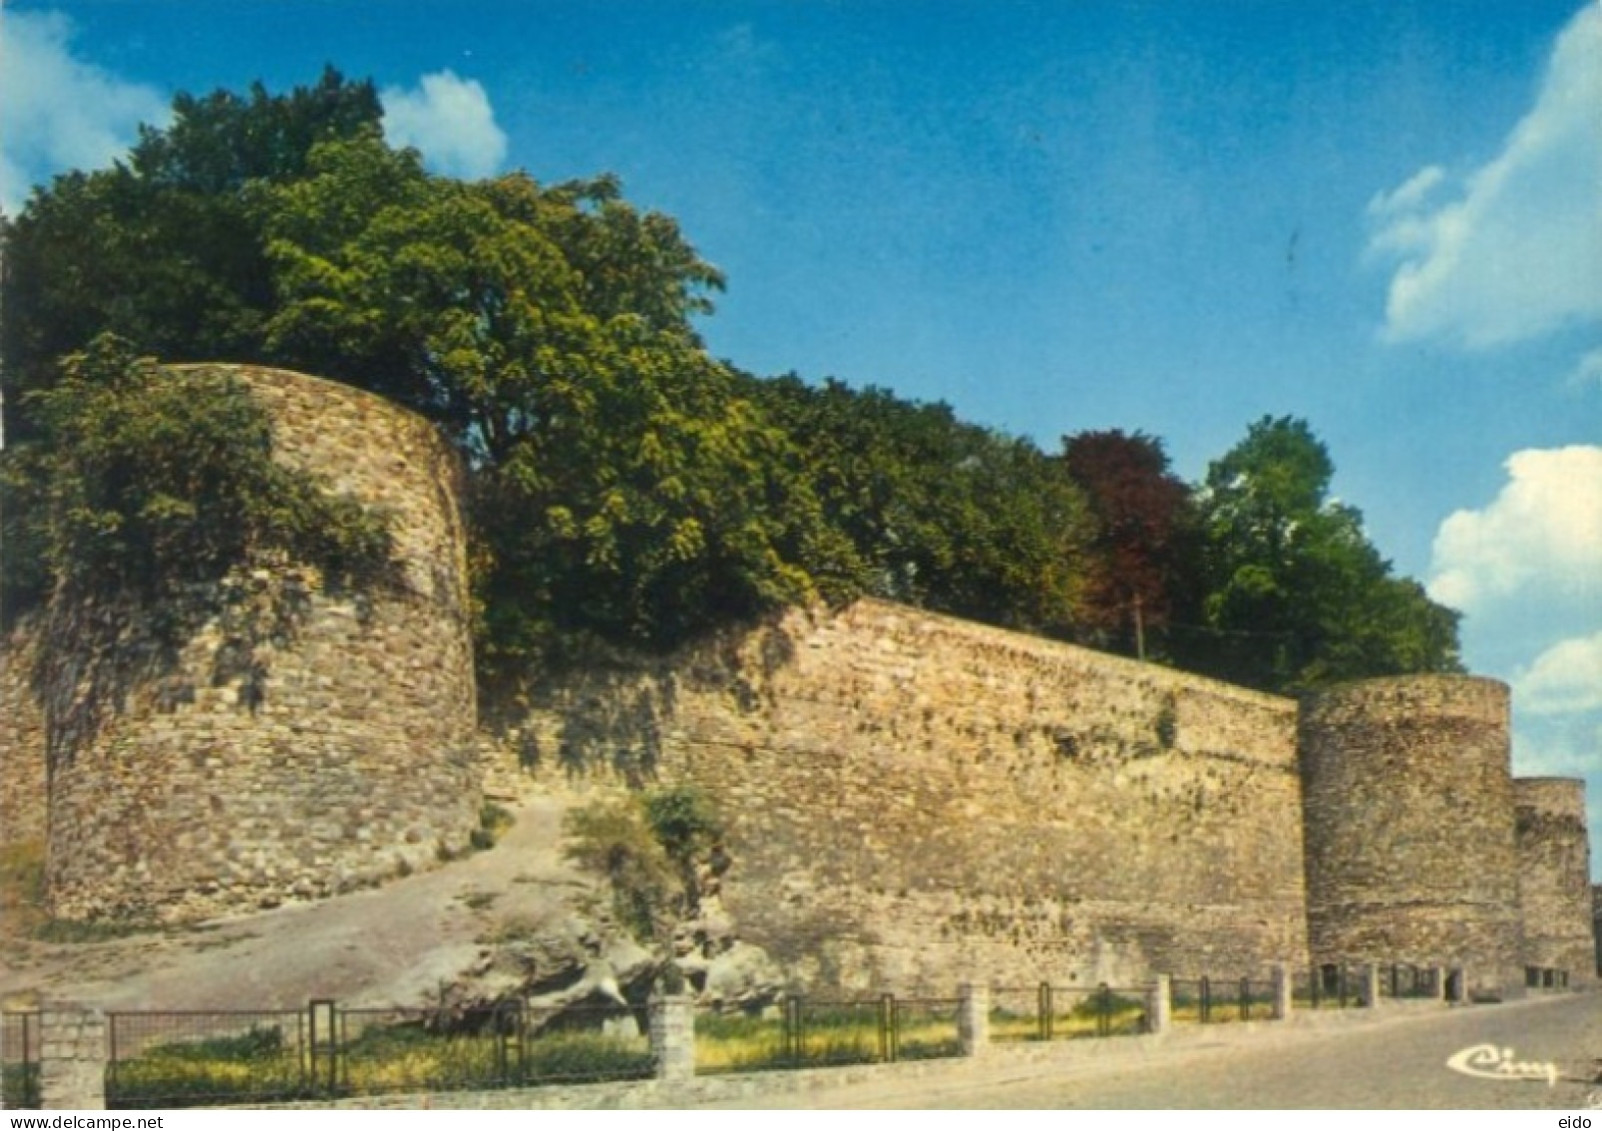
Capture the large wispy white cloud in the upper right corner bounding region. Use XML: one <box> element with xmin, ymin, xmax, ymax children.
<box><xmin>1368</xmin><ymin>3</ymin><xmax>1602</xmax><ymax>348</ymax></box>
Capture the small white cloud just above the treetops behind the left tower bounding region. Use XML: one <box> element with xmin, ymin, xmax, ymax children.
<box><xmin>380</xmin><ymin>70</ymin><xmax>506</xmax><ymax>179</ymax></box>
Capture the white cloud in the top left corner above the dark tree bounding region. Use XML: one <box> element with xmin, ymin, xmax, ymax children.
<box><xmin>0</xmin><ymin>11</ymin><xmax>170</xmax><ymax>216</ymax></box>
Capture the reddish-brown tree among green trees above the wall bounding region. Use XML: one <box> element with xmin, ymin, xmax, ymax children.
<box><xmin>1062</xmin><ymin>429</ymin><xmax>1195</xmax><ymax>654</ymax></box>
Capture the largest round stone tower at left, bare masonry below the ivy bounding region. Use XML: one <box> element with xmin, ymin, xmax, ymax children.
<box><xmin>43</xmin><ymin>367</ymin><xmax>479</xmax><ymax>921</ymax></box>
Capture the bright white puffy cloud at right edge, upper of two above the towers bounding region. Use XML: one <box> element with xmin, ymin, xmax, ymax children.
<box><xmin>1429</xmin><ymin>445</ymin><xmax>1602</xmax><ymax>612</ymax></box>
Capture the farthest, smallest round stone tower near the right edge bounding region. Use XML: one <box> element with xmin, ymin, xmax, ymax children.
<box><xmin>1512</xmin><ymin>777</ymin><xmax>1596</xmax><ymax>987</ymax></box>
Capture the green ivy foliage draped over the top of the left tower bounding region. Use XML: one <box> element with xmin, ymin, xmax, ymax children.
<box><xmin>27</xmin><ymin>335</ymin><xmax>391</xmax><ymax>601</ymax></box>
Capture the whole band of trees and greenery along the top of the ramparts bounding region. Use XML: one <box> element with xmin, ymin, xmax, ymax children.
<box><xmin>0</xmin><ymin>70</ymin><xmax>1458</xmax><ymax>690</ymax></box>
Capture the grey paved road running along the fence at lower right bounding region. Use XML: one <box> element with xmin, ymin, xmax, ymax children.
<box><xmin>711</xmin><ymin>993</ymin><xmax>1602</xmax><ymax>1110</ymax></box>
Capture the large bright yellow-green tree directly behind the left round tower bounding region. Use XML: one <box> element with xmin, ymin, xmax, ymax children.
<box><xmin>258</xmin><ymin>136</ymin><xmax>822</xmax><ymax>660</ymax></box>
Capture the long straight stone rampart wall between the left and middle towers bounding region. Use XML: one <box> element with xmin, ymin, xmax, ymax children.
<box><xmin>511</xmin><ymin>601</ymin><xmax>1307</xmax><ymax>990</ymax></box>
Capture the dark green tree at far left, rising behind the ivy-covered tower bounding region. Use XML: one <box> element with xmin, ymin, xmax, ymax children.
<box><xmin>0</xmin><ymin>69</ymin><xmax>381</xmax><ymax>444</ymax></box>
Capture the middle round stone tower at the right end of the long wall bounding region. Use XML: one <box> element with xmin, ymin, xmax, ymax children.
<box><xmin>1299</xmin><ymin>676</ymin><xmax>1524</xmax><ymax>993</ymax></box>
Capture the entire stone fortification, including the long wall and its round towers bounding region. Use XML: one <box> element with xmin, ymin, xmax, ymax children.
<box><xmin>0</xmin><ymin>368</ymin><xmax>1591</xmax><ymax>990</ymax></box>
